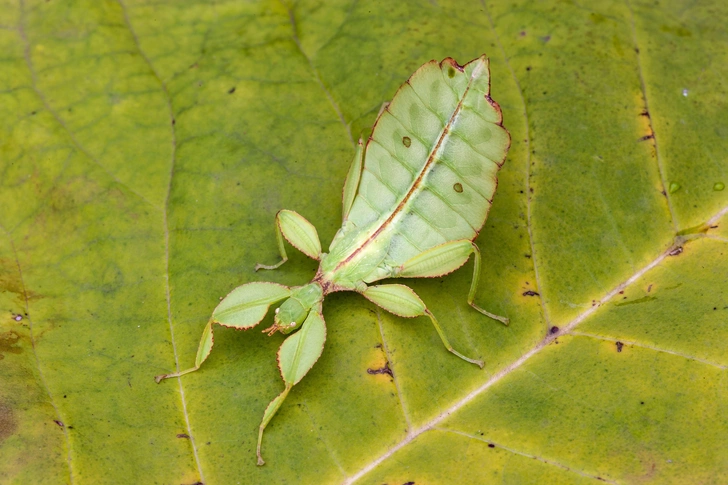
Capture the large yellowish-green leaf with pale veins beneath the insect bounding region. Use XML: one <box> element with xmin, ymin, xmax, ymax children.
<box><xmin>0</xmin><ymin>0</ymin><xmax>728</xmax><ymax>484</ymax></box>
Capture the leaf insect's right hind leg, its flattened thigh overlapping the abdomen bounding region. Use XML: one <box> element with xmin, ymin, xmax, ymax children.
<box><xmin>394</xmin><ymin>239</ymin><xmax>509</xmax><ymax>325</ymax></box>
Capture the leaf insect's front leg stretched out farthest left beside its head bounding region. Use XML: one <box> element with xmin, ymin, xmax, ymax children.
<box><xmin>154</xmin><ymin>283</ymin><xmax>291</xmax><ymax>383</ymax></box>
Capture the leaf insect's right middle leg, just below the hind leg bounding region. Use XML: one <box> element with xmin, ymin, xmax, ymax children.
<box><xmin>362</xmin><ymin>285</ymin><xmax>484</xmax><ymax>368</ymax></box>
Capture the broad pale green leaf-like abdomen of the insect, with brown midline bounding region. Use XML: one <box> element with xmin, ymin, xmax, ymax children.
<box><xmin>349</xmin><ymin>56</ymin><xmax>510</xmax><ymax>263</ymax></box>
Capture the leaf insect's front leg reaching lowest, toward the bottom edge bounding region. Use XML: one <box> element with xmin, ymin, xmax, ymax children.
<box><xmin>257</xmin><ymin>303</ymin><xmax>326</xmax><ymax>465</ymax></box>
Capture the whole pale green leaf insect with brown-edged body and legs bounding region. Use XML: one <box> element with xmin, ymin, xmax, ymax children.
<box><xmin>155</xmin><ymin>55</ymin><xmax>510</xmax><ymax>465</ymax></box>
